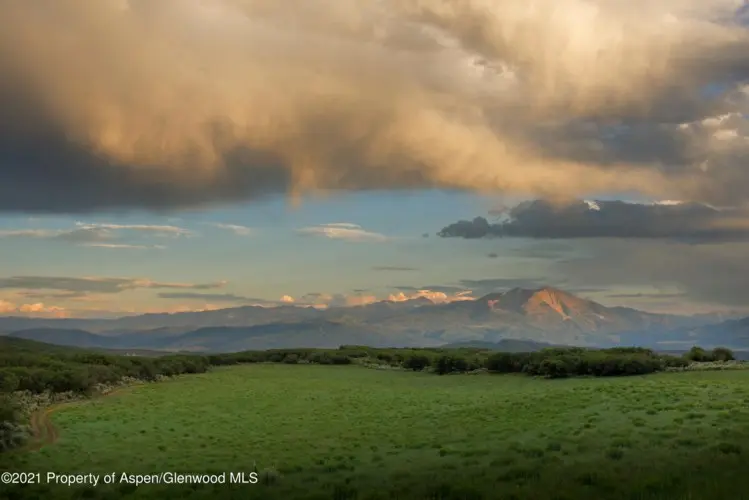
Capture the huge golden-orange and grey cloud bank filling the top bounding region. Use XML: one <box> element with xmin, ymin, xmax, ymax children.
<box><xmin>0</xmin><ymin>0</ymin><xmax>749</xmax><ymax>212</ymax></box>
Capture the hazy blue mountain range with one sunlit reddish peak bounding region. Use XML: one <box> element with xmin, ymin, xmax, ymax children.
<box><xmin>0</xmin><ymin>287</ymin><xmax>749</xmax><ymax>352</ymax></box>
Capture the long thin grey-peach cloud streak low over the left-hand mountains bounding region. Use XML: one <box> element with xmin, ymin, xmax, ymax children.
<box><xmin>0</xmin><ymin>276</ymin><xmax>226</xmax><ymax>293</ymax></box>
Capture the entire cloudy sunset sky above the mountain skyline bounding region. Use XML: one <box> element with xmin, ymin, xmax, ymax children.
<box><xmin>0</xmin><ymin>0</ymin><xmax>749</xmax><ymax>317</ymax></box>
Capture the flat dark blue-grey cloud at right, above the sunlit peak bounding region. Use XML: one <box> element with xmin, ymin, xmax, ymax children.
<box><xmin>439</xmin><ymin>200</ymin><xmax>749</xmax><ymax>243</ymax></box>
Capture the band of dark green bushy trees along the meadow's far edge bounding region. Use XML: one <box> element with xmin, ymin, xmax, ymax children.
<box><xmin>0</xmin><ymin>340</ymin><xmax>733</xmax><ymax>393</ymax></box>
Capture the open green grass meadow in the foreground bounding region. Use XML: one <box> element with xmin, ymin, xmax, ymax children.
<box><xmin>0</xmin><ymin>365</ymin><xmax>749</xmax><ymax>500</ymax></box>
